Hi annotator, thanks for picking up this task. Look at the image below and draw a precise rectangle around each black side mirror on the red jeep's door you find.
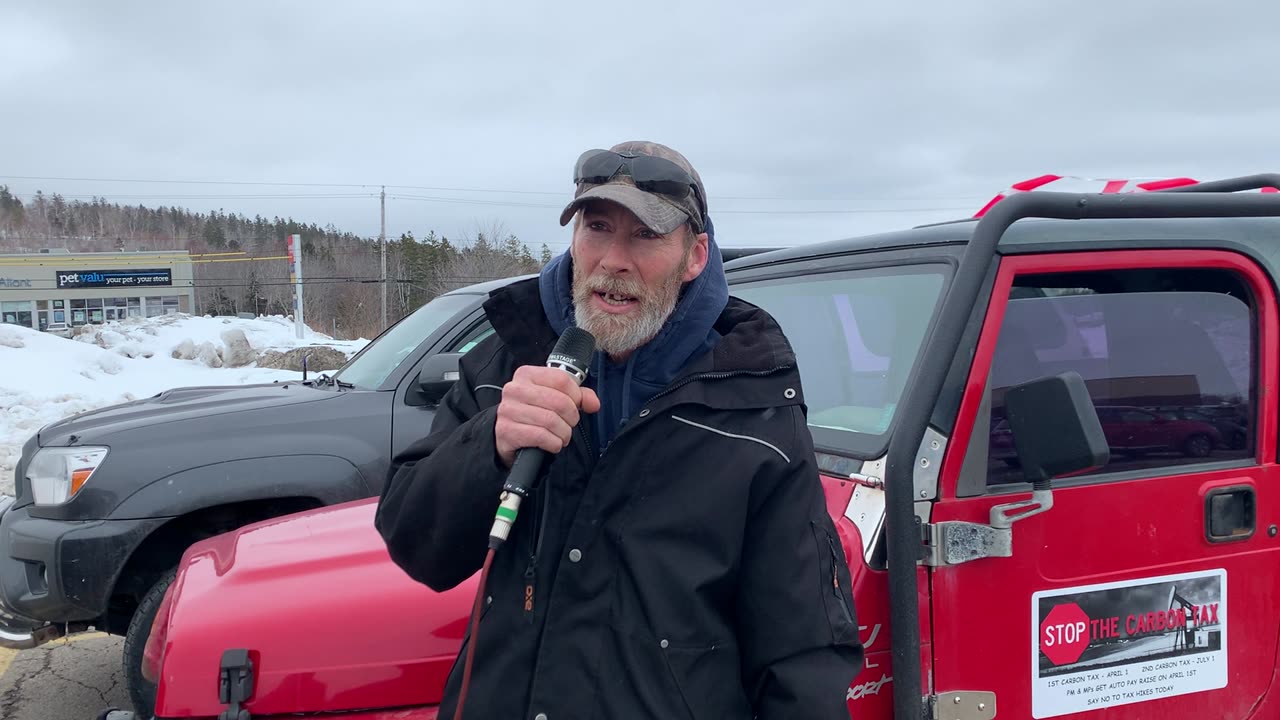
[991,372,1111,528]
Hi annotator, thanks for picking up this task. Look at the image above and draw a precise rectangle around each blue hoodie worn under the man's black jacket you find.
[538,210,728,452]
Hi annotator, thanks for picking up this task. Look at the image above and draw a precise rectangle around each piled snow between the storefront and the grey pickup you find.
[0,314,369,495]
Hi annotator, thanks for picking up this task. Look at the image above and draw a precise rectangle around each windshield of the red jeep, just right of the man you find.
[732,264,947,454]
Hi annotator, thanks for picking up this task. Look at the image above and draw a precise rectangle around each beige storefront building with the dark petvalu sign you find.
[0,250,195,331]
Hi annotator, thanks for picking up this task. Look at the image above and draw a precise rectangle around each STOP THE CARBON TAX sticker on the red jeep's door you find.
[1032,569,1228,717]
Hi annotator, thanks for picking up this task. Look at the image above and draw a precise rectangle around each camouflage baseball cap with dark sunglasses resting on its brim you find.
[561,141,707,234]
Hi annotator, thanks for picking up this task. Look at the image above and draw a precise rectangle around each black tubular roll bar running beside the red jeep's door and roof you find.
[884,184,1280,720]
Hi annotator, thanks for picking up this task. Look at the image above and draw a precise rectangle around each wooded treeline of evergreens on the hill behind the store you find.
[0,186,552,337]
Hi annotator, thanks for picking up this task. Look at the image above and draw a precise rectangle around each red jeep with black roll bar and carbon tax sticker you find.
[112,176,1280,720]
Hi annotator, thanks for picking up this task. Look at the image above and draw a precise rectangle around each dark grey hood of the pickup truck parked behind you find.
[40,382,351,447]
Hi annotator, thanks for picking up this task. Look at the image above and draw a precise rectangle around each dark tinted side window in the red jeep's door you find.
[987,269,1257,484]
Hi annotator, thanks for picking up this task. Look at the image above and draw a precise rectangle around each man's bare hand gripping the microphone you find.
[493,365,600,468]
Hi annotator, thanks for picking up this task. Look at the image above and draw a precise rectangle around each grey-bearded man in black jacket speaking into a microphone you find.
[376,142,863,720]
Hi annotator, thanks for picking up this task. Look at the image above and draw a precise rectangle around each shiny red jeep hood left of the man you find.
[156,498,468,717]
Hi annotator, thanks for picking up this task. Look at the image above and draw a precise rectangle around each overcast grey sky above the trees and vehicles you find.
[0,0,1280,250]
